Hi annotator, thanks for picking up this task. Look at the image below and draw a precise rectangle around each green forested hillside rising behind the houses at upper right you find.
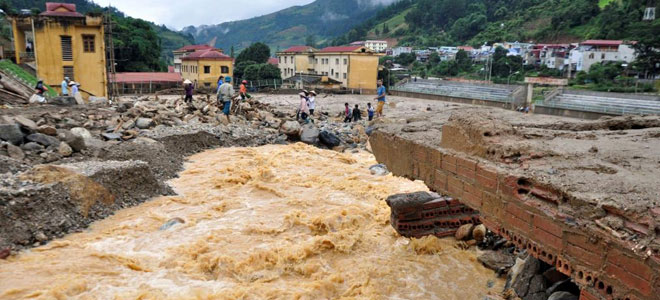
[333,0,658,46]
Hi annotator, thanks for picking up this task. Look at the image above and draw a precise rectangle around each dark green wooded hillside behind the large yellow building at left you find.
[0,0,194,72]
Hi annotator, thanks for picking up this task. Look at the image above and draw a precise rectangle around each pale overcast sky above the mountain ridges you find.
[94,0,314,29]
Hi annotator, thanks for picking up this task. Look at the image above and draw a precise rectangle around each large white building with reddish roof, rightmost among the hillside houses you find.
[570,40,637,72]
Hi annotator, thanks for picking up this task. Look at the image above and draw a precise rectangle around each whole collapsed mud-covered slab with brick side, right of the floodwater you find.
[370,109,660,299]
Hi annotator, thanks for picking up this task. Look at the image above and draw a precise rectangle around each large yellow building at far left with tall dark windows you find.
[11,3,108,97]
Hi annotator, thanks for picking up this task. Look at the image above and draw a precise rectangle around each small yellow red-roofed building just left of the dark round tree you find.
[181,49,234,88]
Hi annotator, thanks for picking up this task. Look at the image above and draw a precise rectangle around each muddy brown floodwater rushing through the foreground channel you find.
[0,144,503,299]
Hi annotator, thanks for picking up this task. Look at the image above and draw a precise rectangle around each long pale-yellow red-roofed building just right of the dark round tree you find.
[277,46,382,93]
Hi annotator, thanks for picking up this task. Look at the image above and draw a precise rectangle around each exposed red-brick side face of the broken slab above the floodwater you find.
[370,131,660,300]
